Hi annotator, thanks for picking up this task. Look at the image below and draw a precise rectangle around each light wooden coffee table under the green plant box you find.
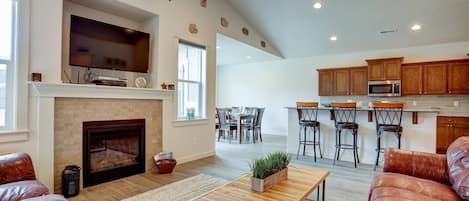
[193,165,329,201]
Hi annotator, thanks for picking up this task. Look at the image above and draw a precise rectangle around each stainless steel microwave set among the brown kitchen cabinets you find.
[368,80,401,96]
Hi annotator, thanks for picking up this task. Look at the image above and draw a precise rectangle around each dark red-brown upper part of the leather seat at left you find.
[0,153,36,184]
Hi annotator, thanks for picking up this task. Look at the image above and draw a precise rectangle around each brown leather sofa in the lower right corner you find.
[368,137,469,201]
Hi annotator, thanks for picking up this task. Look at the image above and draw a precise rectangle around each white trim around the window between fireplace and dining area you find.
[173,37,209,121]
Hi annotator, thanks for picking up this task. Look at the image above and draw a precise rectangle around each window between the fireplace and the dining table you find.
[178,41,206,119]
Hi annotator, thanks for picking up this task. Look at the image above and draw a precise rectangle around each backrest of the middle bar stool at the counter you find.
[331,102,357,126]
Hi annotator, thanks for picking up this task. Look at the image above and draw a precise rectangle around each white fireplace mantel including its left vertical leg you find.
[28,82,174,192]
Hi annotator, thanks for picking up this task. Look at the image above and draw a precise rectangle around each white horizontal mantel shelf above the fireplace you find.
[29,82,174,100]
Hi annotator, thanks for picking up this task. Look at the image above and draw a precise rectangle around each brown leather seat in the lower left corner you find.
[0,153,65,201]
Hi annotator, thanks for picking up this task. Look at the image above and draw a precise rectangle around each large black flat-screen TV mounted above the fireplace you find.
[69,15,150,73]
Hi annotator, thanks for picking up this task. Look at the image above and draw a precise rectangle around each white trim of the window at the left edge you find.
[0,0,30,140]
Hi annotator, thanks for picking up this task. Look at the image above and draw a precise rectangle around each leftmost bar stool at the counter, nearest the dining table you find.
[296,102,322,162]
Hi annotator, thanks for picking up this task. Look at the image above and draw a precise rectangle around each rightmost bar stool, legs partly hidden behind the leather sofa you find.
[373,102,404,171]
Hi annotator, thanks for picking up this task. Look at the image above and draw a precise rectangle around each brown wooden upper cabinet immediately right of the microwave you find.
[402,65,423,96]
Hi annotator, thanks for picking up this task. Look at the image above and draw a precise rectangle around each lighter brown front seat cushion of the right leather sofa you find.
[370,173,460,200]
